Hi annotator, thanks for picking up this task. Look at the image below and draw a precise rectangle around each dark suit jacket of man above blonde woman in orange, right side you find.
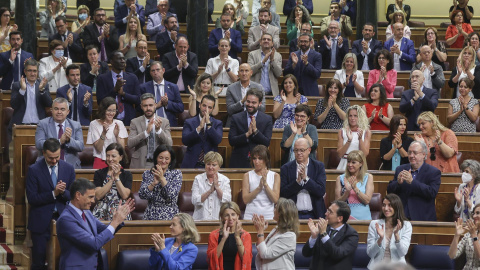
[400,86,438,131]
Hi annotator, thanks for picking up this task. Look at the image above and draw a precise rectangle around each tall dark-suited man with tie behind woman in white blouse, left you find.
[97,51,140,126]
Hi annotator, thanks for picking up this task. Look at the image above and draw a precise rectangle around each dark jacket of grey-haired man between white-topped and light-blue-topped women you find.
[280,158,327,218]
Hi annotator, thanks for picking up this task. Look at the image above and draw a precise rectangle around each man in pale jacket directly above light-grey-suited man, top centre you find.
[247,8,280,51]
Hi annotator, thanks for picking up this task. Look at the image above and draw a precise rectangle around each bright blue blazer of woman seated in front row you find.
[148,237,198,270]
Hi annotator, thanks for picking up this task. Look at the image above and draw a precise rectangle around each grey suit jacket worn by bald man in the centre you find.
[225,81,265,127]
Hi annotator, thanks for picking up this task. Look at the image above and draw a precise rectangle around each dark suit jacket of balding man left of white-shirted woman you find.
[162,51,198,93]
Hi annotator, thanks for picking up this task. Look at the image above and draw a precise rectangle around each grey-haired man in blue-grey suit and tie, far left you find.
[35,97,85,169]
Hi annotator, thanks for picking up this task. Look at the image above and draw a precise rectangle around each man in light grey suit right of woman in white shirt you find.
[248,33,282,97]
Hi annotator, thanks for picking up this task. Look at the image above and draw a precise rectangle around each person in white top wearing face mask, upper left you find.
[39,39,72,92]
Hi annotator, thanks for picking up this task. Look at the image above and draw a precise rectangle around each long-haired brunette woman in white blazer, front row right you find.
[367,194,412,269]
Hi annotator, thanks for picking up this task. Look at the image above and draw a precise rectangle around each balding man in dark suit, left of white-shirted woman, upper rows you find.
[162,37,198,93]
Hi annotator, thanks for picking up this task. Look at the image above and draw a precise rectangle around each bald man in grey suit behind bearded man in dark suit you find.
[226,63,265,127]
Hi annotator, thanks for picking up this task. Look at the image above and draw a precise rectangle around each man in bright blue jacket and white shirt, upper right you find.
[383,23,417,71]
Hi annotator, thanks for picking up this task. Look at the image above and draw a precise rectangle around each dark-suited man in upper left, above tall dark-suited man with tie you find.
[82,8,120,62]
